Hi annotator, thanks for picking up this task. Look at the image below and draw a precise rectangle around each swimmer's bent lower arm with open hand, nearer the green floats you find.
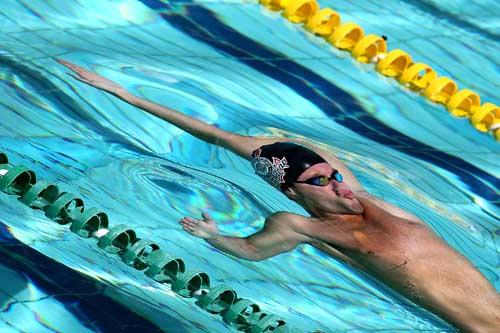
[179,213,308,261]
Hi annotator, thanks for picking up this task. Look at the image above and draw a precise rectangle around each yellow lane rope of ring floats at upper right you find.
[259,0,500,141]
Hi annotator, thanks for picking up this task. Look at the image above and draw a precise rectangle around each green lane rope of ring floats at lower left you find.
[0,152,300,333]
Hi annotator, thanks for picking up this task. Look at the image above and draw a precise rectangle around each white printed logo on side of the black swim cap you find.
[251,149,290,190]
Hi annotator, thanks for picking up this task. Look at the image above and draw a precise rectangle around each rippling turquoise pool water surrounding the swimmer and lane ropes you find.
[0,0,500,333]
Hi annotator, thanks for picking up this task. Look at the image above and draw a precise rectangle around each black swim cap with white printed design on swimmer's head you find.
[250,142,326,190]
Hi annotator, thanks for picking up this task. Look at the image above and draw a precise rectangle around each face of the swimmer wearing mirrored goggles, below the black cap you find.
[285,163,363,214]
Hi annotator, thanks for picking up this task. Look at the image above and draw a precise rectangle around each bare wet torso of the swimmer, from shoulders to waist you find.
[302,198,500,332]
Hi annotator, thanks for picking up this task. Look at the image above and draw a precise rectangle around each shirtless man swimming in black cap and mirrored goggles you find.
[58,60,500,333]
